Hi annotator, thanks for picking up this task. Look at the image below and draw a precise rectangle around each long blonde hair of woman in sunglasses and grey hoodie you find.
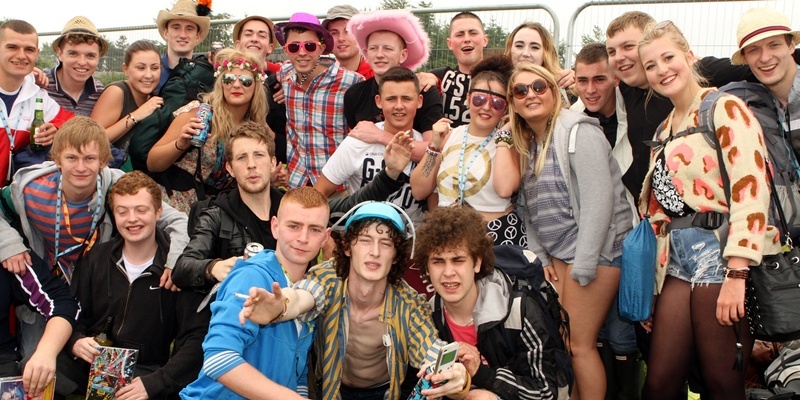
[506,63,565,175]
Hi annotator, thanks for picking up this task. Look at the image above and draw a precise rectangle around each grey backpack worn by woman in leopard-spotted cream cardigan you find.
[684,82,800,230]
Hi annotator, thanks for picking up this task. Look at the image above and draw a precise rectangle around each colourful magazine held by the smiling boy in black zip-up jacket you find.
[86,346,139,400]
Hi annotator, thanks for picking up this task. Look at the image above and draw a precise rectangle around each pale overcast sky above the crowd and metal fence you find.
[7,0,800,60]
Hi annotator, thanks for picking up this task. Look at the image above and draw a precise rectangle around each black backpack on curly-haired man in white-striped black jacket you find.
[494,244,575,399]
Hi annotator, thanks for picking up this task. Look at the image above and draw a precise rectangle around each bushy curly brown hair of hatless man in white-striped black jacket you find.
[414,204,494,281]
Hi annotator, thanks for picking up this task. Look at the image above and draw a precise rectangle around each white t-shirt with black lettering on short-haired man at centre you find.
[322,122,422,224]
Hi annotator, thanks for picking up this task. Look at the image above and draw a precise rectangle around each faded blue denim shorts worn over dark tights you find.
[667,228,725,287]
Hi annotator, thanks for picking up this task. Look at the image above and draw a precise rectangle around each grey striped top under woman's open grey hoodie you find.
[523,141,578,264]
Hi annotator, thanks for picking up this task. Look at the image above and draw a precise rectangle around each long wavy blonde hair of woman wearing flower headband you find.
[202,49,269,142]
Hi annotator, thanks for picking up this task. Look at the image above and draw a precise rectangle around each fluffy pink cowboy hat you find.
[347,10,430,71]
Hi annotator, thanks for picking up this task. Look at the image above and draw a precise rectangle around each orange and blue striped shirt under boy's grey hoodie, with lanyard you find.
[22,172,92,271]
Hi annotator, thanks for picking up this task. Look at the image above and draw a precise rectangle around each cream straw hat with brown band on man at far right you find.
[731,8,800,64]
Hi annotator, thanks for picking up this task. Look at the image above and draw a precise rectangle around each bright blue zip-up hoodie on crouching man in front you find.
[180,250,314,400]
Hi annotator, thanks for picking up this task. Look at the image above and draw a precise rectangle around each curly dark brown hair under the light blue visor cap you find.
[332,217,411,285]
